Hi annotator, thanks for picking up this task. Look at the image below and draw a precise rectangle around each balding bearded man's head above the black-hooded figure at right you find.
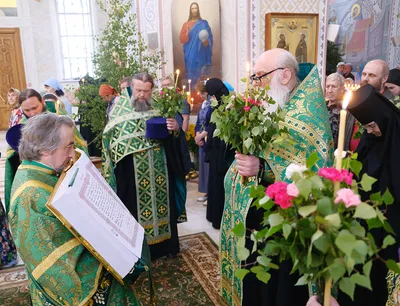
[361,60,389,92]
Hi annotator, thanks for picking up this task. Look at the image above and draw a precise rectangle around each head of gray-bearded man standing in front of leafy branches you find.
[131,72,154,112]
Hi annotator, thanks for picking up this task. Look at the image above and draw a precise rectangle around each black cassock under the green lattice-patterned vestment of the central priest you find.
[114,130,190,260]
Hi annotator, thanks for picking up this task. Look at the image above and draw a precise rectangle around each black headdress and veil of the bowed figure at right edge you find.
[348,85,400,202]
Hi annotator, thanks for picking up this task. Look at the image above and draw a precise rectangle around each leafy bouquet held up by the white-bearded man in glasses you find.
[211,88,288,155]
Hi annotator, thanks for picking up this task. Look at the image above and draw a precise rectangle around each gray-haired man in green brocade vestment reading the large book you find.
[9,113,145,306]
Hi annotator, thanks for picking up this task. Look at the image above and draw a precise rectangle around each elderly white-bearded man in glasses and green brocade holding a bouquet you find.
[220,49,333,306]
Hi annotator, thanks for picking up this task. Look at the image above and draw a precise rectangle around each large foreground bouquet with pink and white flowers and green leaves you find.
[233,154,400,302]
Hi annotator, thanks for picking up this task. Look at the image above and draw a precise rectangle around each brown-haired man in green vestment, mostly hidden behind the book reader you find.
[4,89,88,212]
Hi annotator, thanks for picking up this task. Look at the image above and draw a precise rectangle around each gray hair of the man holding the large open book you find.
[18,113,75,161]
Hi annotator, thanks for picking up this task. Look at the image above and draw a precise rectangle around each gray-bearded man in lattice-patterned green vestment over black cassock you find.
[103,73,190,259]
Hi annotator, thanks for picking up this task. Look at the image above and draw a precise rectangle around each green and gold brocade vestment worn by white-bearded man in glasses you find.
[220,67,333,306]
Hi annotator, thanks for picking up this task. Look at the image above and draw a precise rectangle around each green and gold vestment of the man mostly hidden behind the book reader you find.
[4,111,89,213]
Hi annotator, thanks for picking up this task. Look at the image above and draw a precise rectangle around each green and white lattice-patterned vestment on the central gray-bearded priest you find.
[102,96,171,245]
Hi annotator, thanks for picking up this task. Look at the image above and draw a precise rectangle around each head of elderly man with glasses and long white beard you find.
[250,48,299,111]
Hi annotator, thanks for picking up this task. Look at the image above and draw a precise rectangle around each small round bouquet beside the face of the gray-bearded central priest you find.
[153,87,185,118]
